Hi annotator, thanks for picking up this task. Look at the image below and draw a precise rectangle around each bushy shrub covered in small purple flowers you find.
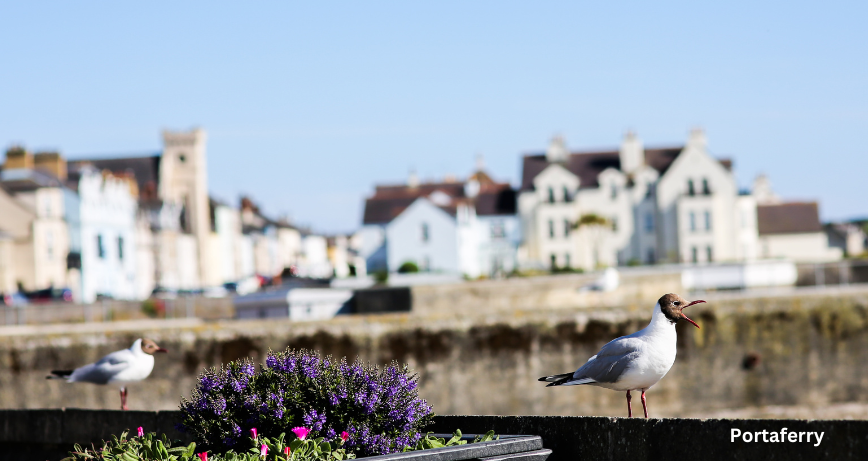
[178,349,432,456]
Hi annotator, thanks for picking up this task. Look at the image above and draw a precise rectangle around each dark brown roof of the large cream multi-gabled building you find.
[521,146,688,190]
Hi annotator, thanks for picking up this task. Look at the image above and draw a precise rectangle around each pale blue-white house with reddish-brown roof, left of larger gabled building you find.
[357,171,521,277]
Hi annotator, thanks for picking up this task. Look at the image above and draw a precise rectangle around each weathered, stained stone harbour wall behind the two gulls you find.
[0,287,868,417]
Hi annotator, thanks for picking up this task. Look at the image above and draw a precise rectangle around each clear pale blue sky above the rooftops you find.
[0,1,868,232]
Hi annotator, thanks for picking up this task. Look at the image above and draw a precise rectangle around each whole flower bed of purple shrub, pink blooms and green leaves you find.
[61,350,544,461]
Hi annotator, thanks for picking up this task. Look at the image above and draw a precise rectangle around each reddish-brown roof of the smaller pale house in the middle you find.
[362,172,516,224]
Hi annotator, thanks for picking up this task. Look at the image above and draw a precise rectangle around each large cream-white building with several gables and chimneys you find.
[518,130,757,270]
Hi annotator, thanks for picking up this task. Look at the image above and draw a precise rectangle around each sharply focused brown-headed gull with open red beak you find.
[539,293,705,418]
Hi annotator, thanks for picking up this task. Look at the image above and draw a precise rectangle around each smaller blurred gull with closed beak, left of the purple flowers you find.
[46,338,168,410]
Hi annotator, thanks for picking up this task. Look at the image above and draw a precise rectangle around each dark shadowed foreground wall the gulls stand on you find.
[0,409,868,461]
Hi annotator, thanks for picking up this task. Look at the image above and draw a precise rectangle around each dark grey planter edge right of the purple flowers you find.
[360,434,552,461]
